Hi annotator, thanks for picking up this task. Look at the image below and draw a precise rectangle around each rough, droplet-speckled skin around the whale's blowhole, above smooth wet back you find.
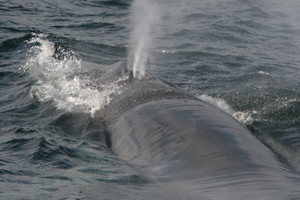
[95,62,197,124]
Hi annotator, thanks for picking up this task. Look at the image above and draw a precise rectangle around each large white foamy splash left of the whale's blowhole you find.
[22,34,119,115]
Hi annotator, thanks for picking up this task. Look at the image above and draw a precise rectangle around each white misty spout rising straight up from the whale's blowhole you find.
[128,0,159,79]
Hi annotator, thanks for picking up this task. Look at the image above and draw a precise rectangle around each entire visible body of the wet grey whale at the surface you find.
[85,63,300,200]
